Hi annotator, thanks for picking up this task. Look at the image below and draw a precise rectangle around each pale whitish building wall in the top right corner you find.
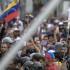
[57,0,70,16]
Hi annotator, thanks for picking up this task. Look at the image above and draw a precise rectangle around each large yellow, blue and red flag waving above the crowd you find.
[0,0,19,22]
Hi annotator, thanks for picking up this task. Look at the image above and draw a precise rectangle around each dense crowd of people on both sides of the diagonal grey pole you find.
[0,14,70,70]
